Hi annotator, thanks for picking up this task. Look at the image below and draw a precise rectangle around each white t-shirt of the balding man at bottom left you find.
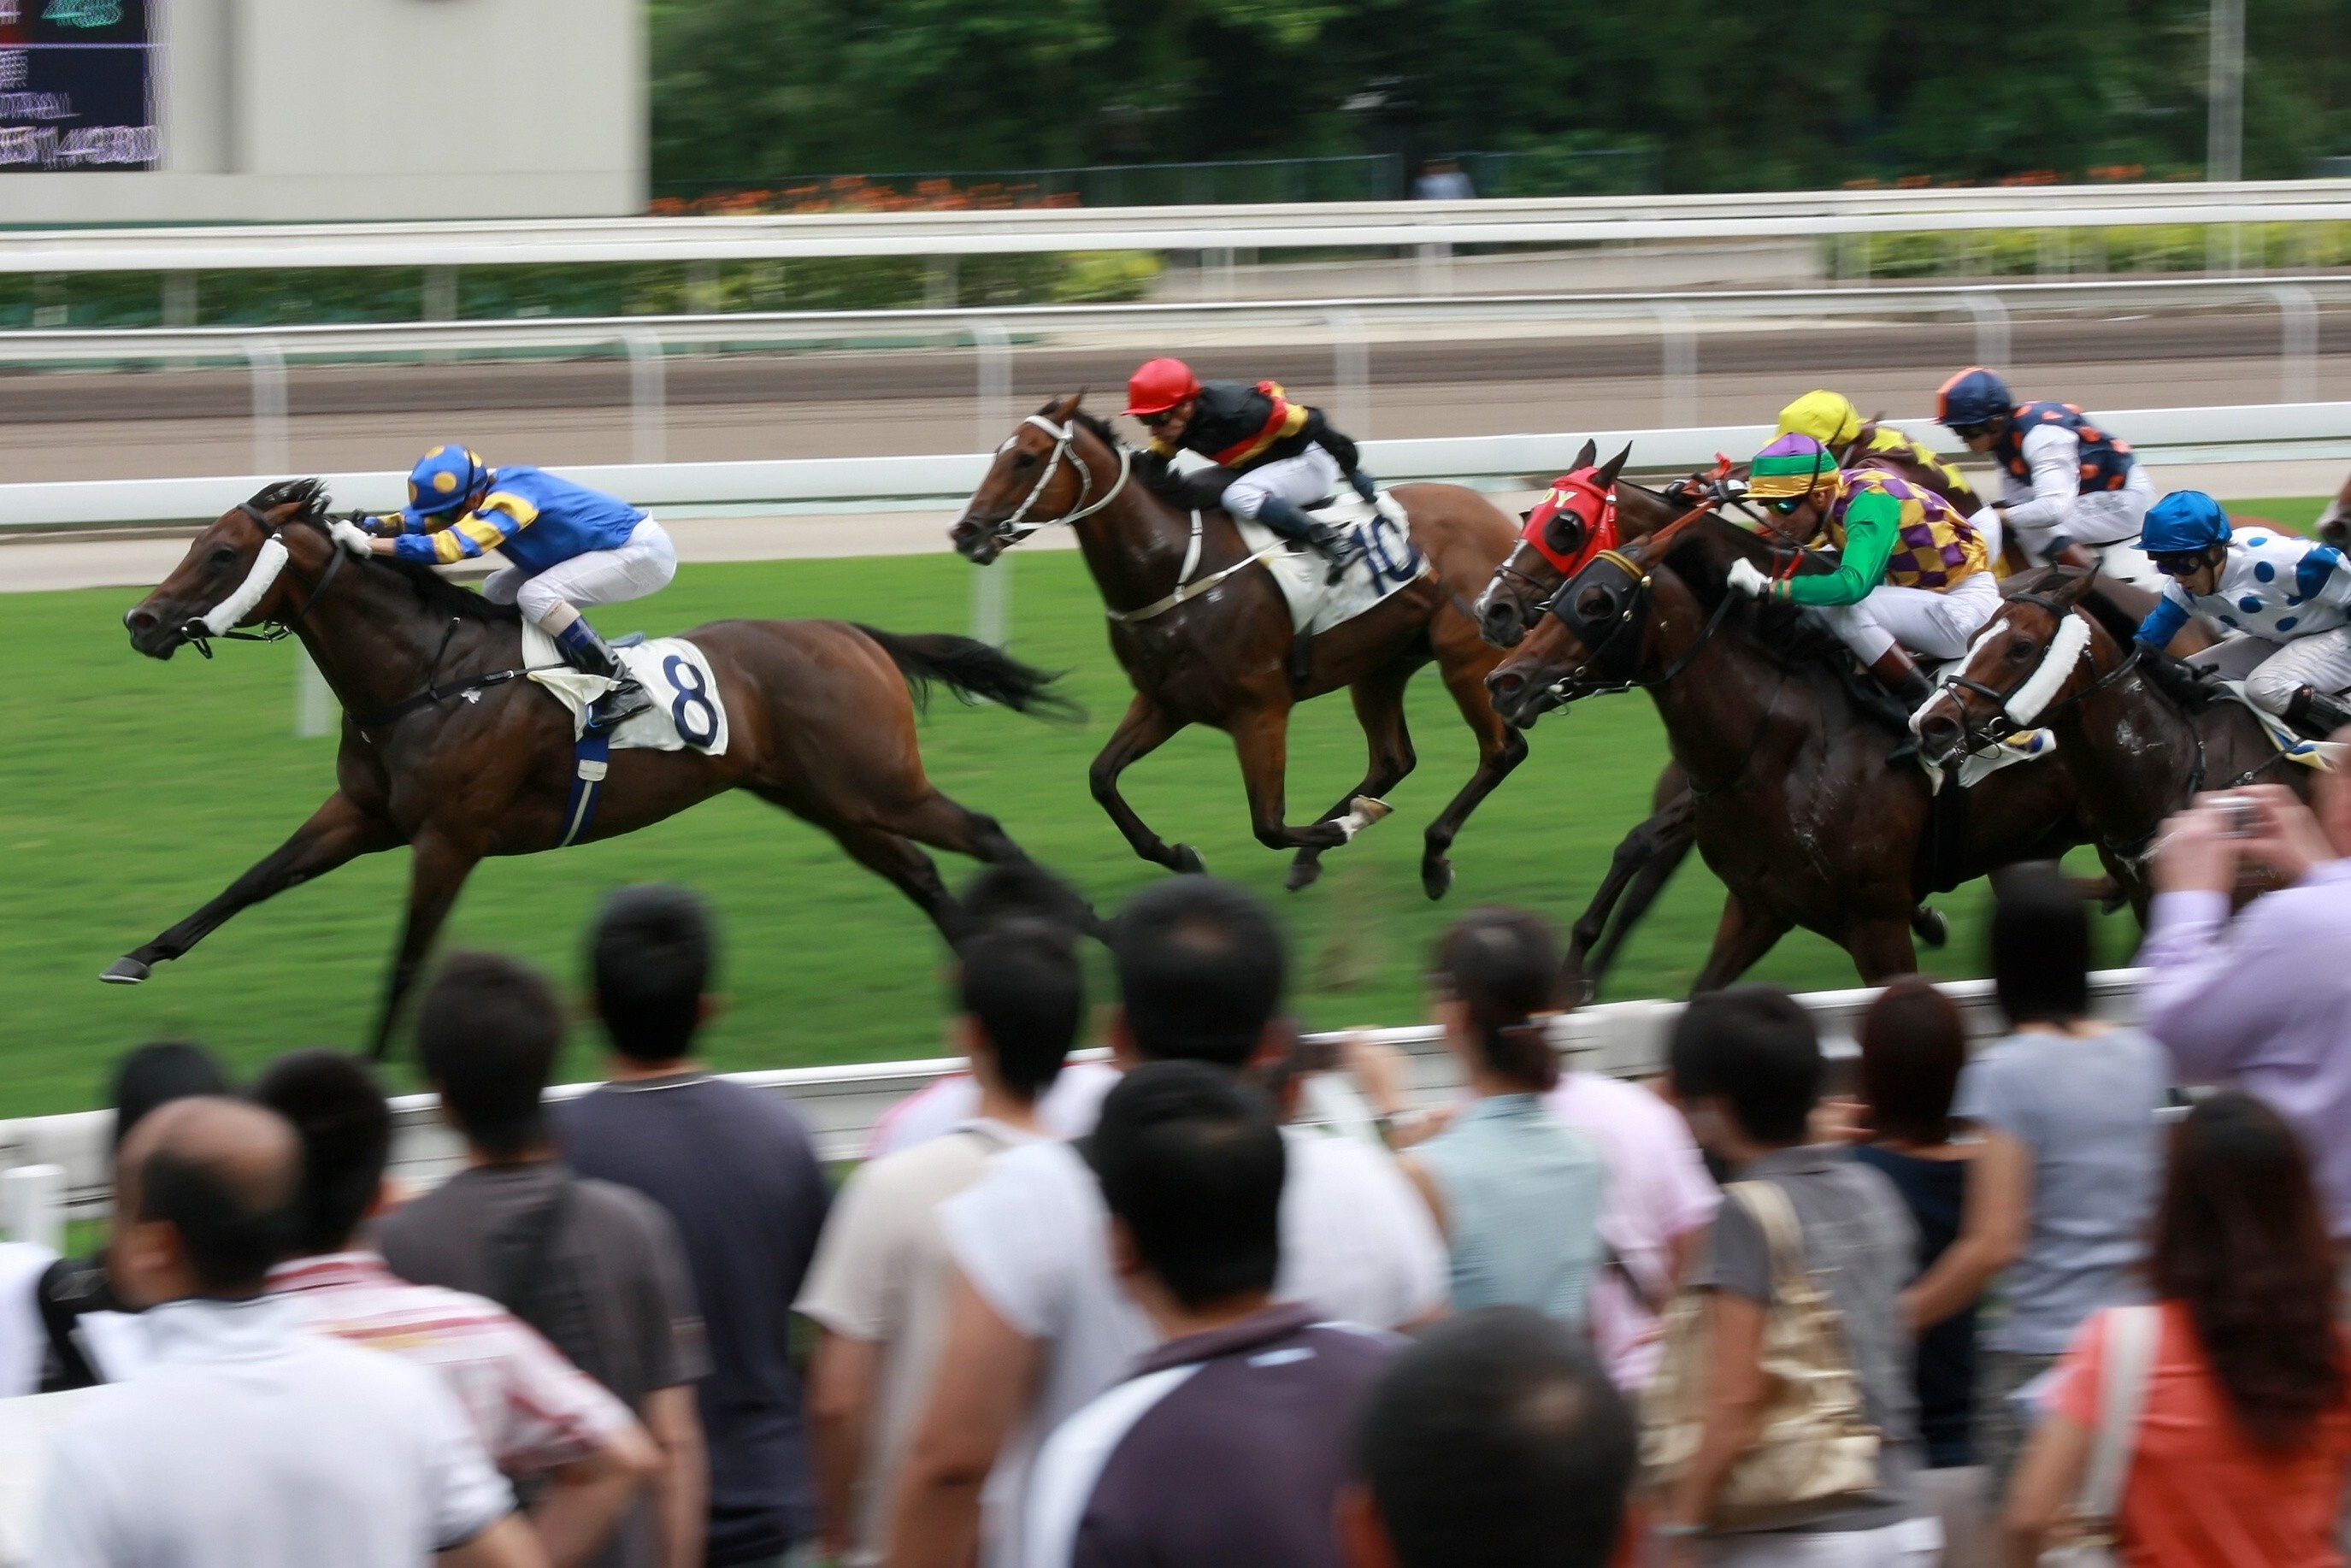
[33,1295,515,1568]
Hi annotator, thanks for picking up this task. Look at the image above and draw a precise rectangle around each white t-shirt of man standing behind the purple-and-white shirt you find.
[938,1129,1448,1568]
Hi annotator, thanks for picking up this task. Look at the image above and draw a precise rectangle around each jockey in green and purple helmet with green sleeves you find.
[1730,435,2000,742]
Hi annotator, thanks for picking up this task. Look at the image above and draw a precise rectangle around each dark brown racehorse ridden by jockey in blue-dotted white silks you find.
[1912,567,2311,926]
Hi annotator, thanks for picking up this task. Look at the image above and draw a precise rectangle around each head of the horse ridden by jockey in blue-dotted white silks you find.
[1912,567,2097,766]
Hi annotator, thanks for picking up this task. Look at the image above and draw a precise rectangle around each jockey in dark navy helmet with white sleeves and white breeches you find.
[1935,364,2163,590]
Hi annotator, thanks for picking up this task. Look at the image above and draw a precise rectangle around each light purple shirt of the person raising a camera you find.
[2140,860,2351,1241]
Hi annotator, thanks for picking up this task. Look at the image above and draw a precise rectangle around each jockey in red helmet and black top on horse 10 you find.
[1126,360,1378,564]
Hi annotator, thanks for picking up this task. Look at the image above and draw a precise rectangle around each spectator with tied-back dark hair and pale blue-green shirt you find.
[1404,910,1606,1326]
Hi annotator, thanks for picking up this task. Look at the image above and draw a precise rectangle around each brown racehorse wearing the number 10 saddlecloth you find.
[950,392,1526,898]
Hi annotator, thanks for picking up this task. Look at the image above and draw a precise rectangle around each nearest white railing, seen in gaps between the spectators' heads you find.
[0,969,2140,1229]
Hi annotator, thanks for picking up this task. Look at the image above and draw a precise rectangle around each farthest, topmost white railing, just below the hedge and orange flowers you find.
[0,181,2351,273]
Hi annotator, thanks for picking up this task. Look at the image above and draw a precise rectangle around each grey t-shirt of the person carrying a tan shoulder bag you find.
[1693,1145,1924,1530]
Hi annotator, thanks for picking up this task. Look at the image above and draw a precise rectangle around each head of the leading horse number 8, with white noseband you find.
[122,480,336,658]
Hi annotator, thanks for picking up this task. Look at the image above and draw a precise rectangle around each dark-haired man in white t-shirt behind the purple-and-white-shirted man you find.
[889,877,1444,1568]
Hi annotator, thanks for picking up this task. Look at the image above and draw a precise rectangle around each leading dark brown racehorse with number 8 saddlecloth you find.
[106,480,1081,1056]
